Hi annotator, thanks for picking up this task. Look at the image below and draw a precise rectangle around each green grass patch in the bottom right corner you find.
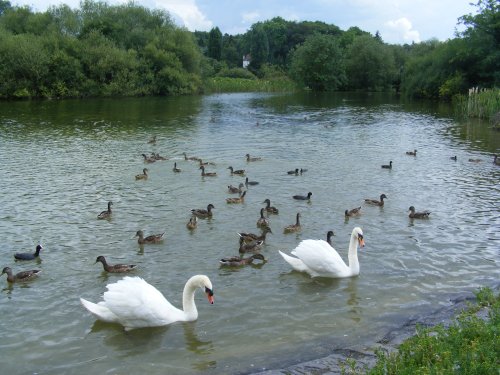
[366,288,500,375]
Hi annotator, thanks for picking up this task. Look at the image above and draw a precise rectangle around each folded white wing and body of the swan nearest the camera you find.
[101,277,185,328]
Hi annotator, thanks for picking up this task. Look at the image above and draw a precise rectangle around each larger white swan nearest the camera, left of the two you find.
[80,275,214,330]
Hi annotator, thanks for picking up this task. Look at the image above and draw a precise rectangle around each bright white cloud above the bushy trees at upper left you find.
[156,0,213,31]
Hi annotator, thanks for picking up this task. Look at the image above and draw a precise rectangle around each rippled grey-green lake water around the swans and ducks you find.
[0,94,500,374]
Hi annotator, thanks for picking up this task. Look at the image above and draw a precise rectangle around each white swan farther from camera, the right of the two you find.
[280,227,365,278]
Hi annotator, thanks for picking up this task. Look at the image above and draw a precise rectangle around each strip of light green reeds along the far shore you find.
[204,77,296,93]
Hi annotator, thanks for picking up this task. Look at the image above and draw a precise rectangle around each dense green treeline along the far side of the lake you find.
[0,0,500,99]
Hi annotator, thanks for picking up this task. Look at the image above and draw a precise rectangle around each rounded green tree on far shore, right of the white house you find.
[290,34,346,91]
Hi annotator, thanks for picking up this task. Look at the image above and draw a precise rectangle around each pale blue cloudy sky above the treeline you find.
[10,0,477,44]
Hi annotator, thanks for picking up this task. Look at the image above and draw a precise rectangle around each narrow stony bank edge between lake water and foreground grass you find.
[256,284,500,375]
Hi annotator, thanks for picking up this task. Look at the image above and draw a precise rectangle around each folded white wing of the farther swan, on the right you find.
[292,240,351,277]
